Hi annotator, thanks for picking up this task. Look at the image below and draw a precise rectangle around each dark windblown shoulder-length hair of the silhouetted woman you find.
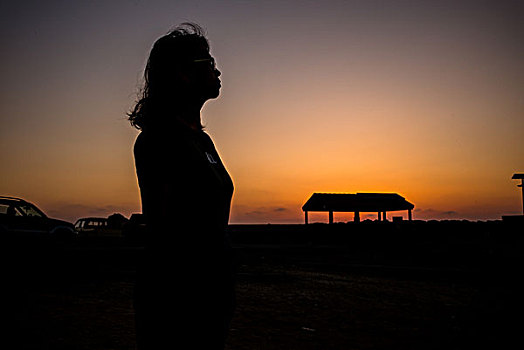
[127,23,209,129]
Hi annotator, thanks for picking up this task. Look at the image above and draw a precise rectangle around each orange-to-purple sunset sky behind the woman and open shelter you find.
[0,0,524,223]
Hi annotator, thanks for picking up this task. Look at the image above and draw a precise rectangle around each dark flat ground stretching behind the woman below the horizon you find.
[2,221,524,350]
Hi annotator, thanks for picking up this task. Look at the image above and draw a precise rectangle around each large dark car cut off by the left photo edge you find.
[0,196,77,239]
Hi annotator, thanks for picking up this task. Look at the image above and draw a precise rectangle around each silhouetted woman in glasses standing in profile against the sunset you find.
[129,23,234,349]
